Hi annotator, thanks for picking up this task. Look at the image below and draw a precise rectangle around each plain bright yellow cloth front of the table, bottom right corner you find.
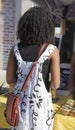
[53,114,75,130]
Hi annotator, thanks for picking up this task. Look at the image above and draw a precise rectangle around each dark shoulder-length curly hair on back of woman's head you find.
[17,7,54,45]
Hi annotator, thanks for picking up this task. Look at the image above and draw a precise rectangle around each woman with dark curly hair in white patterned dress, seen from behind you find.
[6,7,60,130]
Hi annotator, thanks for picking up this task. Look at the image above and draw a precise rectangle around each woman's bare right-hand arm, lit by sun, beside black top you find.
[49,48,60,89]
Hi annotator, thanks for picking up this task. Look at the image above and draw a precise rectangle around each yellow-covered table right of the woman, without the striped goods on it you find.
[53,95,75,130]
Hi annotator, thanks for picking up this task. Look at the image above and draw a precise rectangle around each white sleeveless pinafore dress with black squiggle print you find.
[10,43,56,130]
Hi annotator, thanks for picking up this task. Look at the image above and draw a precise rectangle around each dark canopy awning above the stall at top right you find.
[31,0,75,20]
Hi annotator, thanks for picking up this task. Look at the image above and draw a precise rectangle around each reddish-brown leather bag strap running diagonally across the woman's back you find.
[21,43,48,92]
